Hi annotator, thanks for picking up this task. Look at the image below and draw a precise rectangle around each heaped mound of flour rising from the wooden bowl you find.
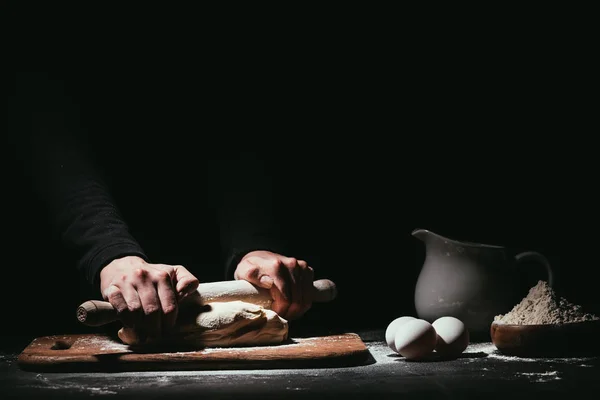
[494,281,600,325]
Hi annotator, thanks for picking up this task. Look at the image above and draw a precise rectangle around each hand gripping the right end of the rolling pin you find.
[233,250,314,320]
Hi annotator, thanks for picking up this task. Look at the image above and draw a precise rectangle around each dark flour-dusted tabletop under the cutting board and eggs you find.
[0,330,600,400]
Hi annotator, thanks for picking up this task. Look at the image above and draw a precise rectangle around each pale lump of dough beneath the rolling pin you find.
[118,301,288,348]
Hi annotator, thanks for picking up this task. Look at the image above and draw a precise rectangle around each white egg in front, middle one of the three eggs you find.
[394,319,437,360]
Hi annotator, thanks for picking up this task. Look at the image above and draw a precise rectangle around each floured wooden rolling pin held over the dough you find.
[77,279,337,326]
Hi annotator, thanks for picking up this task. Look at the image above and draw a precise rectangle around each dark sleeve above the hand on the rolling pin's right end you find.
[208,149,288,280]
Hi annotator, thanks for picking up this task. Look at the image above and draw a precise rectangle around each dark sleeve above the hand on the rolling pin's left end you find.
[9,72,146,288]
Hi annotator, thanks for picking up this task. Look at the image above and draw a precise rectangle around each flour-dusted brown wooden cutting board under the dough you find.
[17,333,374,372]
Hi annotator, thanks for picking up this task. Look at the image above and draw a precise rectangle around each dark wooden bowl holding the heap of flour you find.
[490,321,600,358]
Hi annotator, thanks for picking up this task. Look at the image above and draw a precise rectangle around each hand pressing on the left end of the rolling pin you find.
[100,256,199,342]
